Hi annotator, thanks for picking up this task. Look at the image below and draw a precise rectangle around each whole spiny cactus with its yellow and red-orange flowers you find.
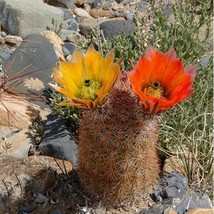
[49,46,196,205]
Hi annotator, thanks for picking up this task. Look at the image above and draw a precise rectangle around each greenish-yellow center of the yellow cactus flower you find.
[76,79,101,100]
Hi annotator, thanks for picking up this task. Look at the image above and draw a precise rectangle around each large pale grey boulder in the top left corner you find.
[0,0,64,37]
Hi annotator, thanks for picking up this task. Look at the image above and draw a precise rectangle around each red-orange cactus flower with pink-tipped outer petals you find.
[128,47,196,114]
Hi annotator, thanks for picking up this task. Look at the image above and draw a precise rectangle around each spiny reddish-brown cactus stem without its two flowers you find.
[78,76,159,204]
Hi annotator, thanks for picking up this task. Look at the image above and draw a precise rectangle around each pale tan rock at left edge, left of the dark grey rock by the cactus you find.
[0,126,35,158]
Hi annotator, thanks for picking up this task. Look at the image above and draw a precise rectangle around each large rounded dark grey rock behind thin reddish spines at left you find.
[3,34,58,107]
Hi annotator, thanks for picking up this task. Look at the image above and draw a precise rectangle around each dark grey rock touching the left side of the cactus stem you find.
[39,114,77,167]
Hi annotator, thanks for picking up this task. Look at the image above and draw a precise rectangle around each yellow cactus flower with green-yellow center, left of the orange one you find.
[50,46,120,109]
